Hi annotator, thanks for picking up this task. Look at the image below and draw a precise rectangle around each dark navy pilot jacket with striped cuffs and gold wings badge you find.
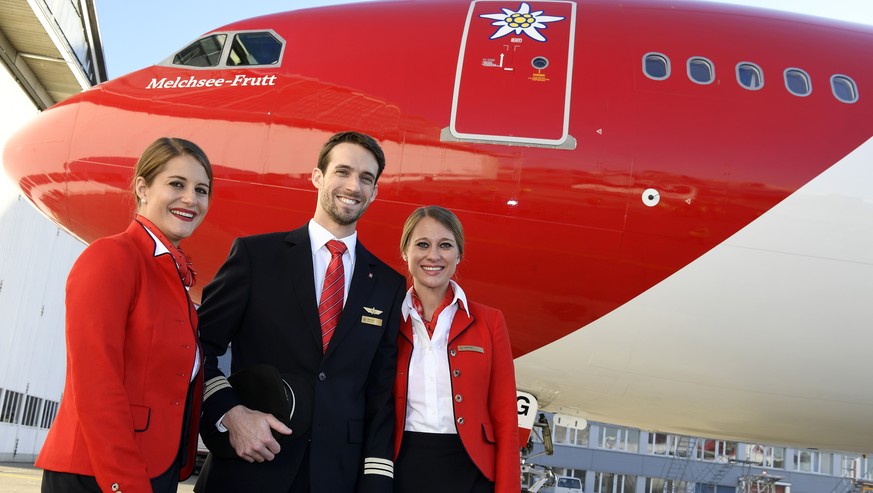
[199,225,405,493]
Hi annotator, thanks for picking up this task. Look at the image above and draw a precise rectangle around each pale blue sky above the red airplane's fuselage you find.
[97,0,873,78]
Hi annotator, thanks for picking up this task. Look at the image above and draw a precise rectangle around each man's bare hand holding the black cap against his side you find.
[221,405,291,462]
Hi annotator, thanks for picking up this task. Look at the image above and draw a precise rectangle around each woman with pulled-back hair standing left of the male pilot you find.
[36,138,212,493]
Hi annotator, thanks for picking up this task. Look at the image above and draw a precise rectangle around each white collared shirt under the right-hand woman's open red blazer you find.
[401,281,470,433]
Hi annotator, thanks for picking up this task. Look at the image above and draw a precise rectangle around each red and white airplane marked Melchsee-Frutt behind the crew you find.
[4,0,873,453]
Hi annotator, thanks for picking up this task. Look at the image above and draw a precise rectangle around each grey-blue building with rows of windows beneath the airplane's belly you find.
[522,414,873,493]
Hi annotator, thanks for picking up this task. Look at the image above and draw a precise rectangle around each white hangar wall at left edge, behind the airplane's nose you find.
[0,57,85,462]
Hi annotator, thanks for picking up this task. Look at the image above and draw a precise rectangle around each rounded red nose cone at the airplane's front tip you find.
[3,104,78,229]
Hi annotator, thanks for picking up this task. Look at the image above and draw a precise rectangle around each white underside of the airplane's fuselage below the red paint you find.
[515,139,873,452]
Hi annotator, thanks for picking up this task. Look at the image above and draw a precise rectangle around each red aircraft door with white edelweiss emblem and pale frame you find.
[442,0,576,148]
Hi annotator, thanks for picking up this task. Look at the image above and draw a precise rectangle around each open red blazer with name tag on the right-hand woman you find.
[394,303,521,493]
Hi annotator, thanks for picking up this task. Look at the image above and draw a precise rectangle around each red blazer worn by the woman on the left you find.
[36,221,203,493]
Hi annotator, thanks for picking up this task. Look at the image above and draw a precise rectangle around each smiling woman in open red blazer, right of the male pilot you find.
[394,206,521,493]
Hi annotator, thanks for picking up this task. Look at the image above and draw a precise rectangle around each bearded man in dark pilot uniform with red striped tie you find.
[195,132,405,493]
